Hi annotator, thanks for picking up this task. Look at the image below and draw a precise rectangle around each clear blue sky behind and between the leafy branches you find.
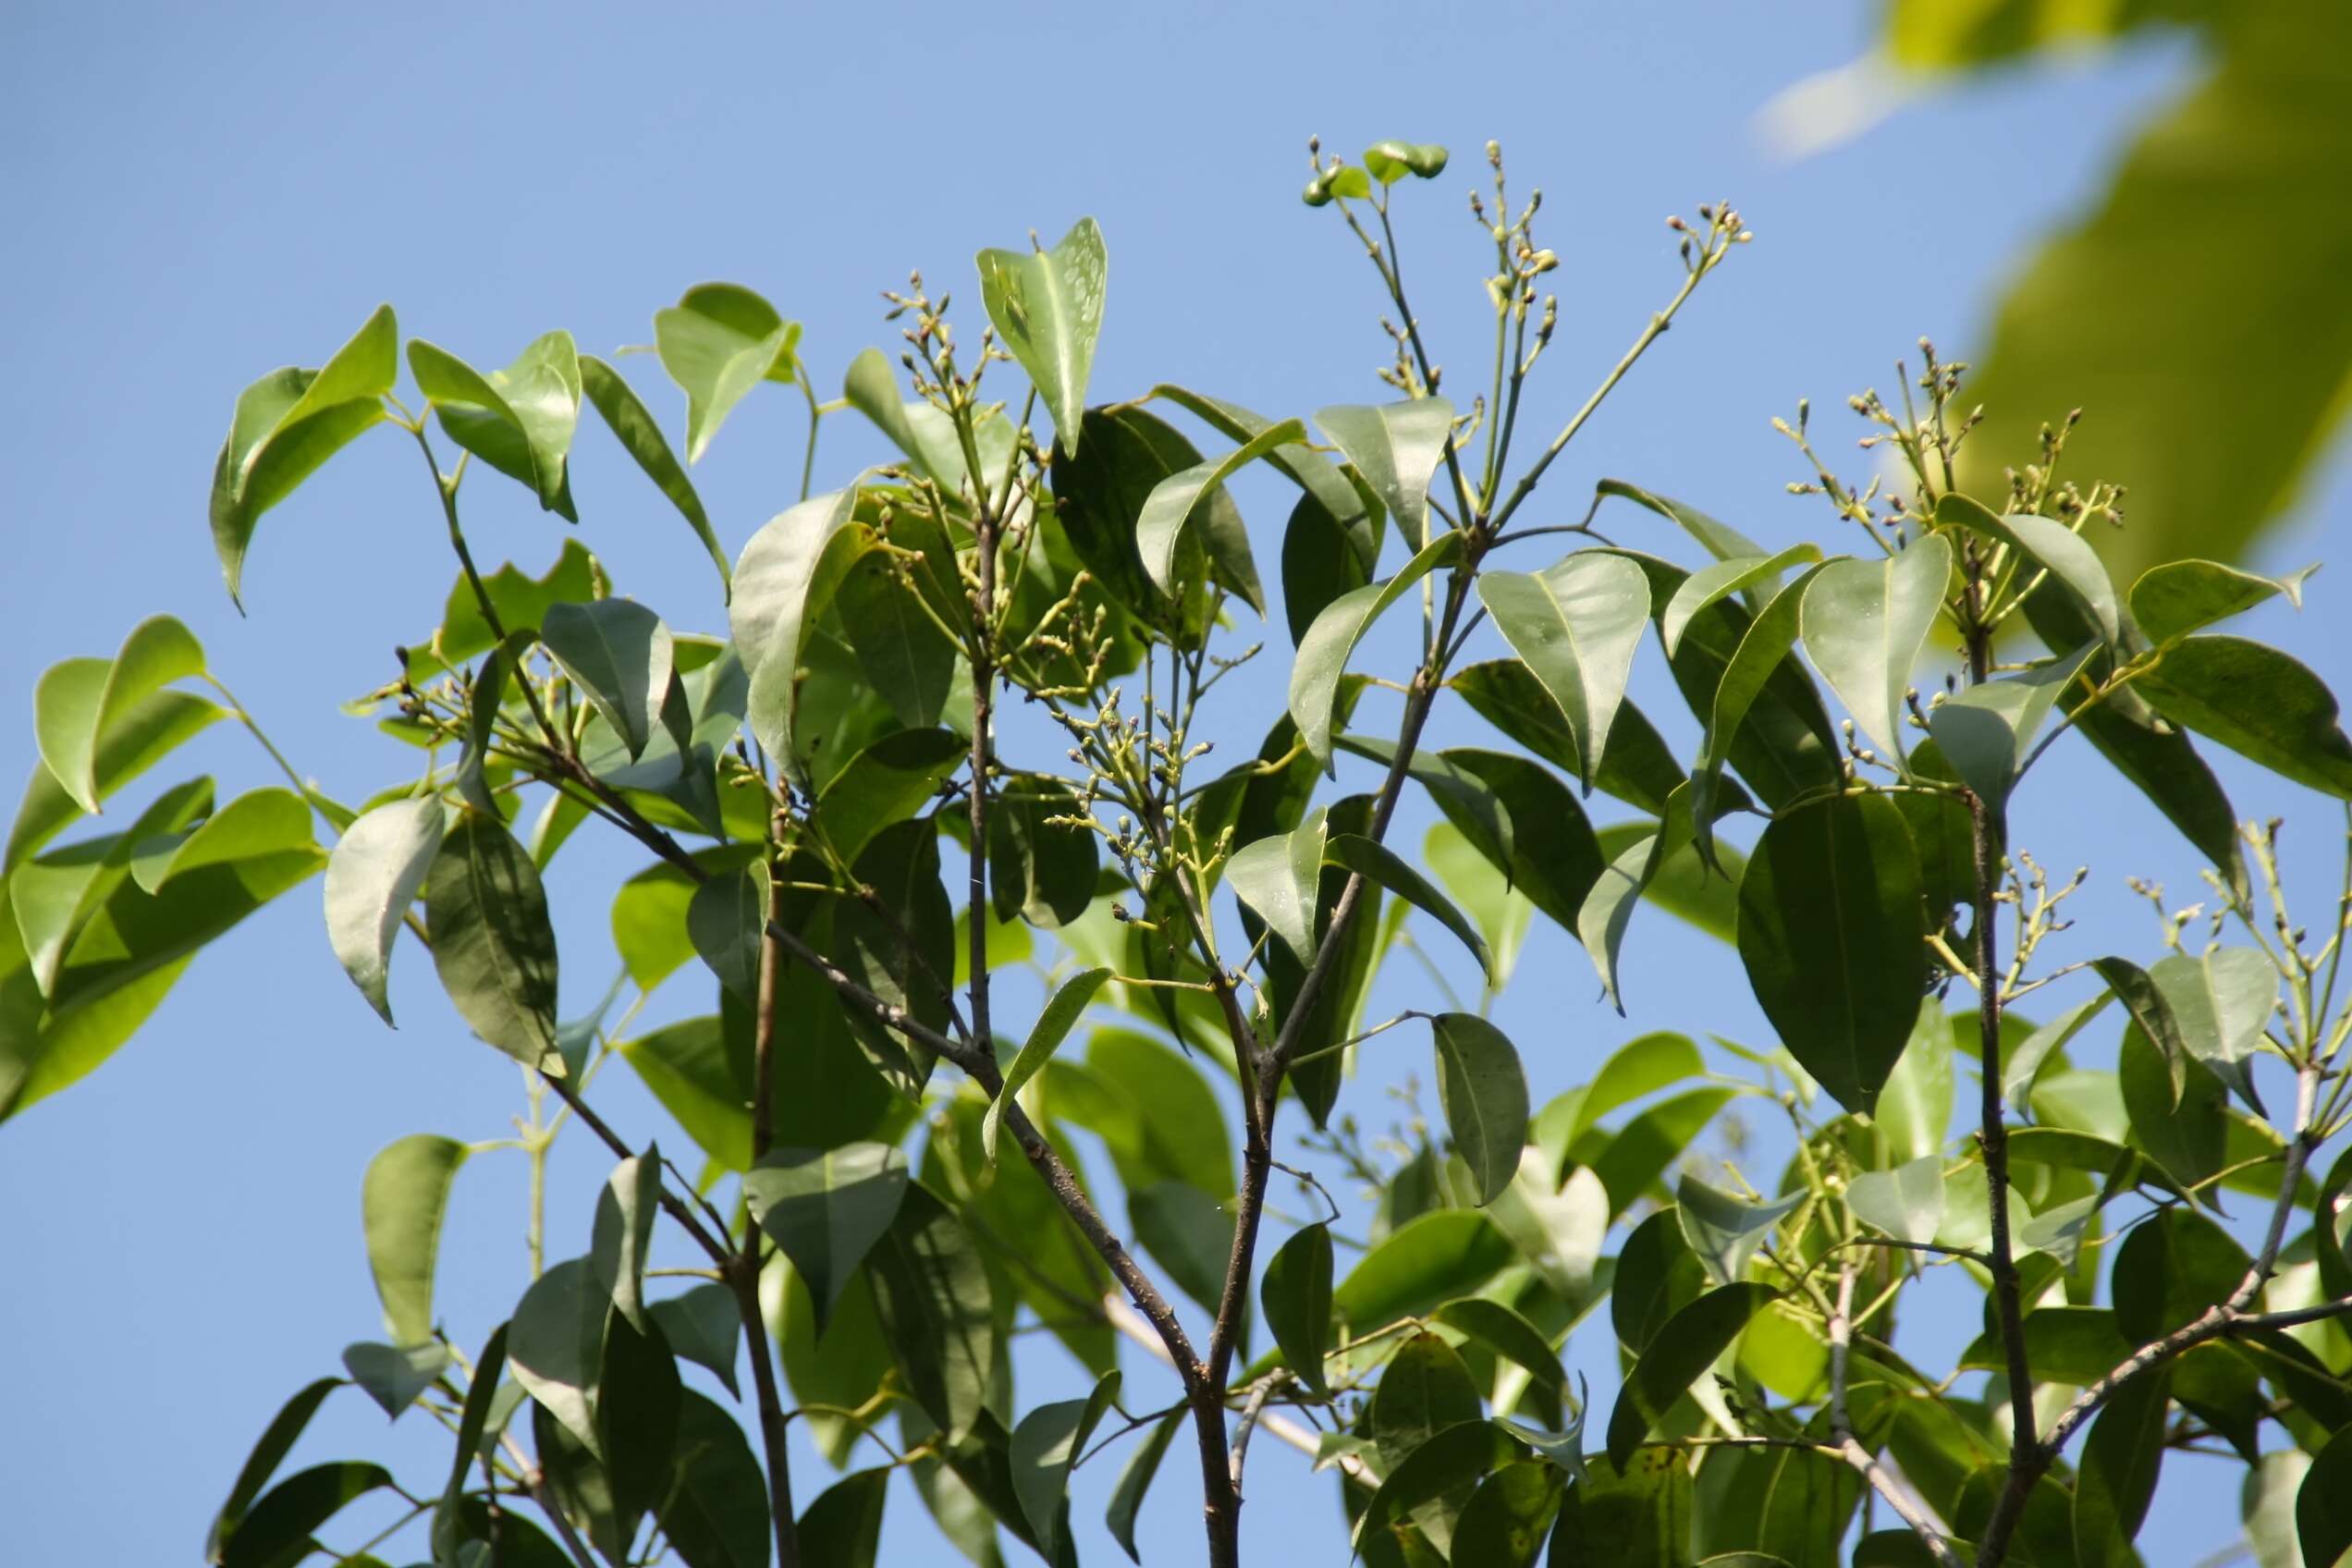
[0,0,2352,1568]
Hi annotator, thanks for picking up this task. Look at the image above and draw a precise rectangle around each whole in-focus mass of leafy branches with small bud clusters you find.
[13,131,2352,1568]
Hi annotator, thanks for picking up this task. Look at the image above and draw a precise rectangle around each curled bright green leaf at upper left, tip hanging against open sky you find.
[212,306,399,604]
